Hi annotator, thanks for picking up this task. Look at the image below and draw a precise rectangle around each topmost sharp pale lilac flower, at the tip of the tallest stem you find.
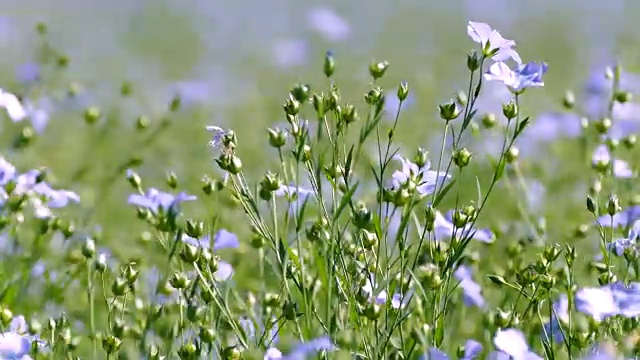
[467,21,522,64]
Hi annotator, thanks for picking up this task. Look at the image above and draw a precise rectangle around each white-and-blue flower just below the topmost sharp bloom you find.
[484,61,548,93]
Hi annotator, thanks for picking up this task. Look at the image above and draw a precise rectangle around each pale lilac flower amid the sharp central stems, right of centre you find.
[391,155,451,195]
